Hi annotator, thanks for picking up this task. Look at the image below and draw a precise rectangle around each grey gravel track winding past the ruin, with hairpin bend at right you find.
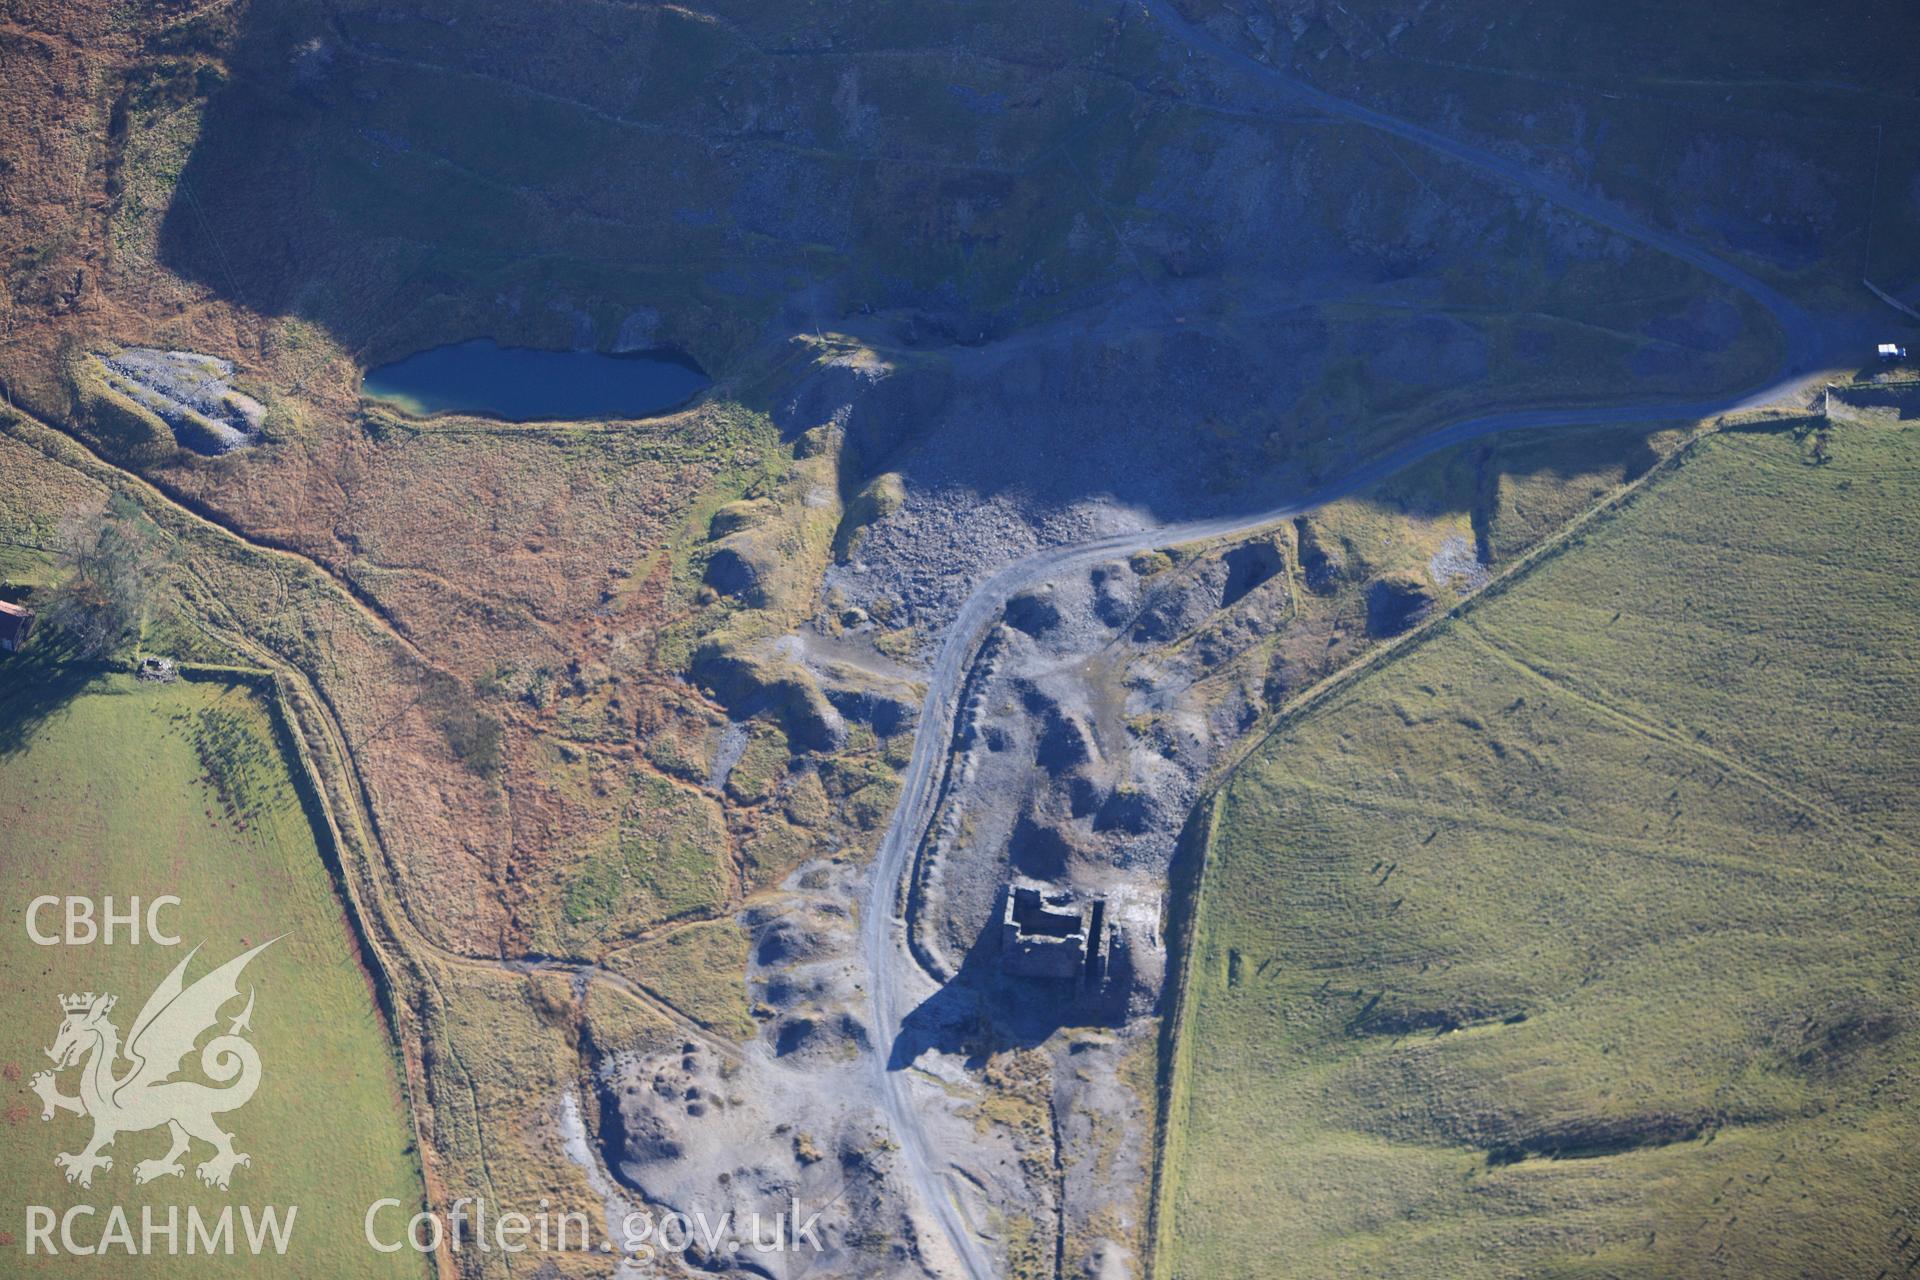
[860,12,1822,1280]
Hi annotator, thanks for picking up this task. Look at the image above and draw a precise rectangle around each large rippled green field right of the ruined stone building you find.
[1158,430,1920,1280]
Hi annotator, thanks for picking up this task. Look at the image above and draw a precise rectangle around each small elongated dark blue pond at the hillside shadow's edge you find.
[361,338,712,422]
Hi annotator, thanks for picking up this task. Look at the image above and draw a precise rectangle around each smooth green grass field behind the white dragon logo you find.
[0,675,424,1278]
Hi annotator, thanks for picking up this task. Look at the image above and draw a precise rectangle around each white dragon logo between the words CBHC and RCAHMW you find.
[33,938,278,1190]
